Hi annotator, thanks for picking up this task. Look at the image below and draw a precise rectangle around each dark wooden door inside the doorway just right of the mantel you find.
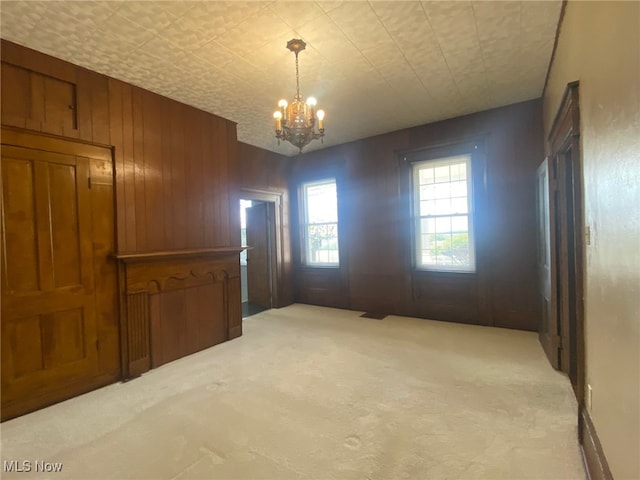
[246,202,271,308]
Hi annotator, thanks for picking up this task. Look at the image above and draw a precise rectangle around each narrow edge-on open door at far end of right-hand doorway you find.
[536,158,560,368]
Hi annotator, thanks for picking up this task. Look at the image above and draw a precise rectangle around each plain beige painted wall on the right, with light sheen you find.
[543,1,640,479]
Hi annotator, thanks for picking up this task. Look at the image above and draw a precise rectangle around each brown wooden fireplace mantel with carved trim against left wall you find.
[113,247,244,379]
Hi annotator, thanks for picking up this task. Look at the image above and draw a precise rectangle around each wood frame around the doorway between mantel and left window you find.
[238,188,286,308]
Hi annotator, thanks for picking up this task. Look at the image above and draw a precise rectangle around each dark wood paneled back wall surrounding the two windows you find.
[292,100,543,330]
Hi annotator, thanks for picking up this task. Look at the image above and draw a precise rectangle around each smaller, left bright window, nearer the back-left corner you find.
[301,178,339,267]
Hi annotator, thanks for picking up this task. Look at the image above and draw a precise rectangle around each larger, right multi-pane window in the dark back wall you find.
[413,155,475,272]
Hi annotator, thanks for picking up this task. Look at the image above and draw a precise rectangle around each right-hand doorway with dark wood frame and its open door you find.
[538,82,585,408]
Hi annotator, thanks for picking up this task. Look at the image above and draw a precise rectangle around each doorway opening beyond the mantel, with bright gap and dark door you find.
[240,198,275,318]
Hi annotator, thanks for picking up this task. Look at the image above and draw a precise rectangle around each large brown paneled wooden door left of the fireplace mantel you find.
[0,145,99,418]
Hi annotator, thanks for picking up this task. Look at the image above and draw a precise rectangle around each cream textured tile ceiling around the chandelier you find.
[0,0,561,155]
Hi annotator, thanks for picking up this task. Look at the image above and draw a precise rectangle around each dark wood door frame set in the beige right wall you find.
[547,82,585,410]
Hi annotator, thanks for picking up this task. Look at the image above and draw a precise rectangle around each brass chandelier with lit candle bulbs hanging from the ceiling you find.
[273,38,324,152]
